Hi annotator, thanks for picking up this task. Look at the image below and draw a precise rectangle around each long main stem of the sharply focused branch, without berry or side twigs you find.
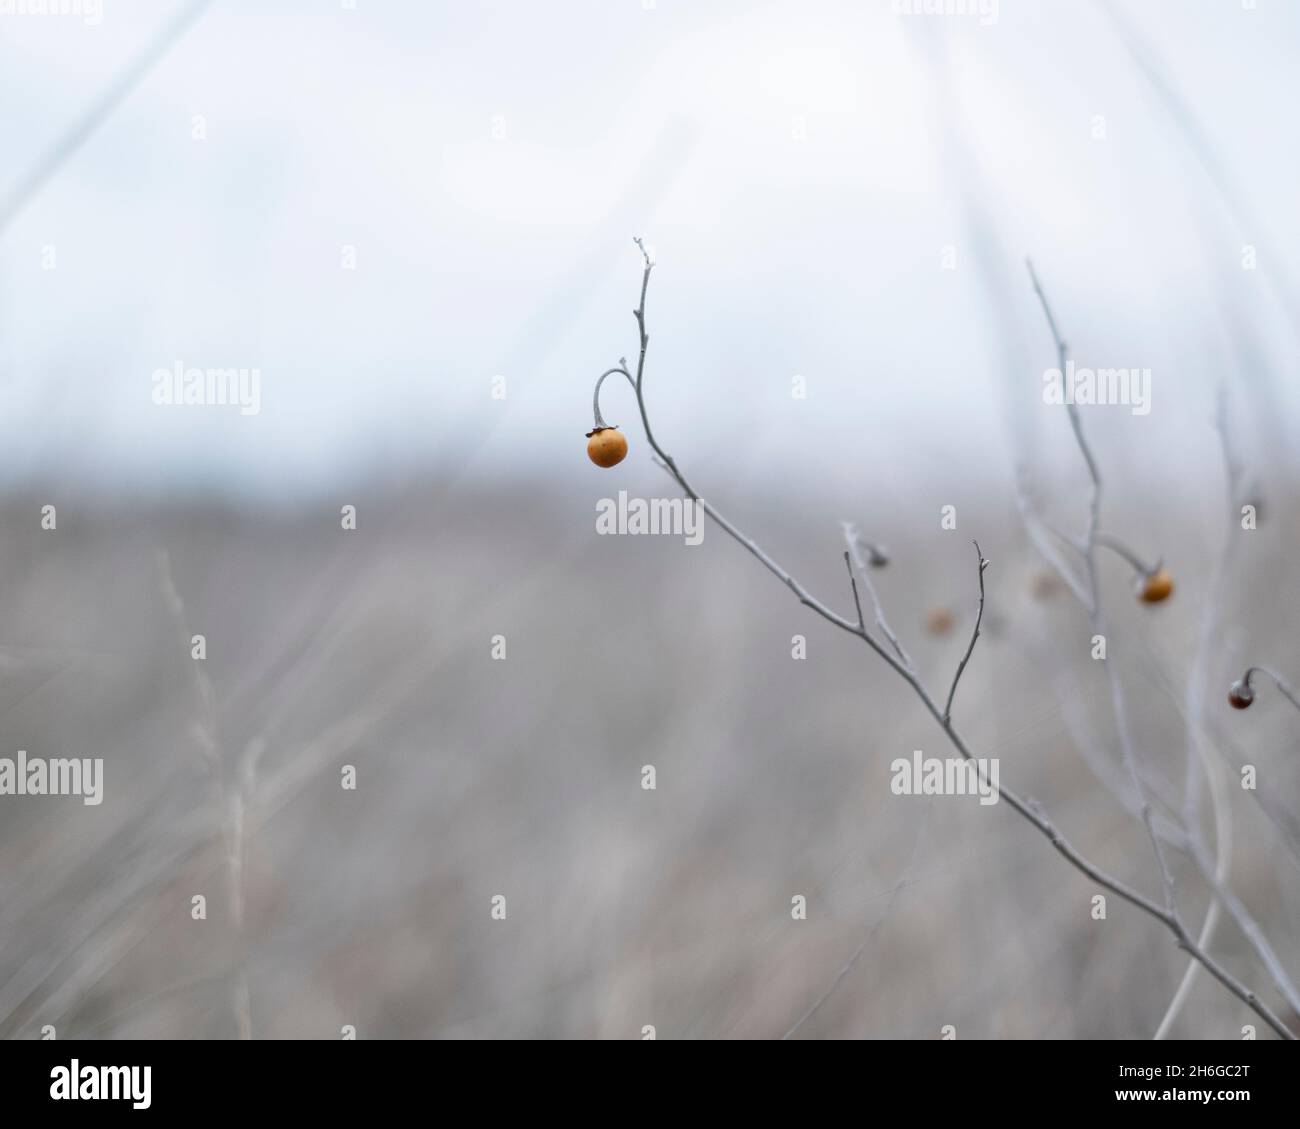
[603,239,1295,1039]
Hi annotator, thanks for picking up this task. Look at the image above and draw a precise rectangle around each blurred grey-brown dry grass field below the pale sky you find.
[0,470,1300,1038]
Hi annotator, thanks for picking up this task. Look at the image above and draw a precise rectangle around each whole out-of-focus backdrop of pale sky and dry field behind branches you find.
[0,0,1300,1038]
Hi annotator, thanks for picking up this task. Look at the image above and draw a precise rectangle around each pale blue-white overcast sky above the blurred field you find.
[0,0,1300,494]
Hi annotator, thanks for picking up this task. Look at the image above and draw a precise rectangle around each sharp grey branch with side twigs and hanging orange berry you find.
[589,238,1295,1039]
